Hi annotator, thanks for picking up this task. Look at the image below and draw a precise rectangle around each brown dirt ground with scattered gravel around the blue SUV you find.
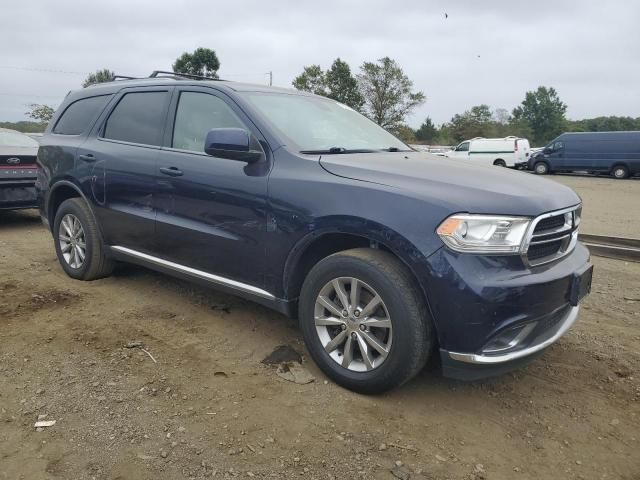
[0,177,640,480]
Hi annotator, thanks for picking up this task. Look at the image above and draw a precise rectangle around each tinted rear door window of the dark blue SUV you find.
[104,92,167,145]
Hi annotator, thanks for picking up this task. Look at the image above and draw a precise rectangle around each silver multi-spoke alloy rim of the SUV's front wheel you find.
[314,277,392,372]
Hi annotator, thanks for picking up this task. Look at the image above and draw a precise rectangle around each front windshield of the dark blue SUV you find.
[242,92,411,153]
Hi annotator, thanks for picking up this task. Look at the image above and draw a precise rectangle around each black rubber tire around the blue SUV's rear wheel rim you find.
[53,198,114,280]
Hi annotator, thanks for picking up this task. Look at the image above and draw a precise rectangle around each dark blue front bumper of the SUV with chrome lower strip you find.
[427,243,591,380]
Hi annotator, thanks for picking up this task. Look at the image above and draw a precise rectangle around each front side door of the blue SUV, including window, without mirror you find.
[155,87,270,288]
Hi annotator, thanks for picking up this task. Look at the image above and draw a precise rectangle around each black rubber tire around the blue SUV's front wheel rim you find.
[299,248,433,393]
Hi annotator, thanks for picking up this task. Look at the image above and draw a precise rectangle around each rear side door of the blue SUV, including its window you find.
[78,87,172,253]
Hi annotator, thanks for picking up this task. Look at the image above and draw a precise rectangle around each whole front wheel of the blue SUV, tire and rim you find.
[299,248,432,393]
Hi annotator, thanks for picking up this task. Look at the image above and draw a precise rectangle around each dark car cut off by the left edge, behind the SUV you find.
[0,128,38,210]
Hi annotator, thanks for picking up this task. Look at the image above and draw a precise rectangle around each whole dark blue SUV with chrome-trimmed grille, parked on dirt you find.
[37,72,592,392]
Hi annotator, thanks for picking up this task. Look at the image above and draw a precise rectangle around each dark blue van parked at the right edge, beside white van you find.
[528,132,640,178]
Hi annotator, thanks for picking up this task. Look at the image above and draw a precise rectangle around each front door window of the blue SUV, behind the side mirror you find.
[172,92,245,152]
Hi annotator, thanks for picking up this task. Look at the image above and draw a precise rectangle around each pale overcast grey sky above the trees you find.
[0,0,640,127]
